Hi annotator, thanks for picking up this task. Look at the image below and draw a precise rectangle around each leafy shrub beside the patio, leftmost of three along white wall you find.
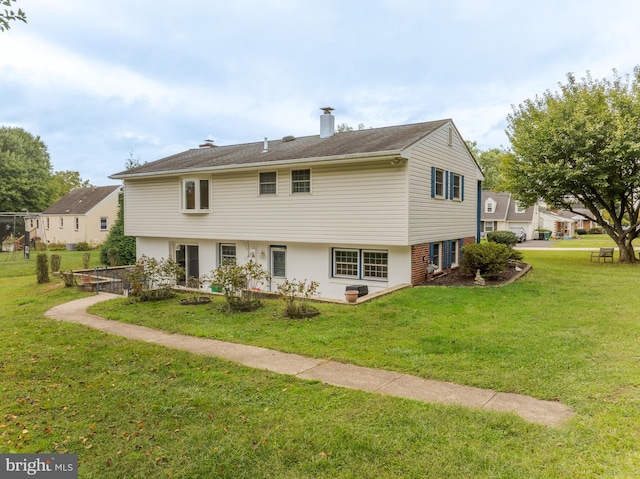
[126,255,184,301]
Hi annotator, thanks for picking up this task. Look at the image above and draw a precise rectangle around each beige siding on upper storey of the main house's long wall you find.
[125,161,407,245]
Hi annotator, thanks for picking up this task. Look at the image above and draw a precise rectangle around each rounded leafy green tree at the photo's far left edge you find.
[0,127,54,211]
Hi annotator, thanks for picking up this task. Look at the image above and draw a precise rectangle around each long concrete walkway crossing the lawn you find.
[45,293,574,427]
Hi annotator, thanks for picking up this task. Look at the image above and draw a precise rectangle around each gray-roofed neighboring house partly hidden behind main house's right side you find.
[480,191,539,240]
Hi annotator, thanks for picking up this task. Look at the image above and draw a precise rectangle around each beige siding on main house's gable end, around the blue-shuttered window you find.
[407,125,478,244]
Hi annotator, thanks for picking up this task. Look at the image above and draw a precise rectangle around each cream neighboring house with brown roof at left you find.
[40,185,122,249]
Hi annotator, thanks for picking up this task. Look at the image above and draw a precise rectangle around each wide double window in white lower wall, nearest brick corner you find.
[333,248,389,280]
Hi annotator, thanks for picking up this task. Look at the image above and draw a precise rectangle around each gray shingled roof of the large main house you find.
[111,120,451,179]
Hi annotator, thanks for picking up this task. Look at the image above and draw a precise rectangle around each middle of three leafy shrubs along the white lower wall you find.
[211,261,269,311]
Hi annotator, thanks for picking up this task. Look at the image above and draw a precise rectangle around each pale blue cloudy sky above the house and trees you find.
[0,0,640,185]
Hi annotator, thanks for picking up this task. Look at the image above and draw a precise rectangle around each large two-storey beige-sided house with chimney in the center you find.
[111,109,483,299]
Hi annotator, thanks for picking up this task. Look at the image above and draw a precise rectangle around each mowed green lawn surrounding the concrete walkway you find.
[0,251,640,478]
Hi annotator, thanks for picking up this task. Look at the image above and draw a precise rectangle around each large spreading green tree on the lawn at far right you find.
[504,67,640,263]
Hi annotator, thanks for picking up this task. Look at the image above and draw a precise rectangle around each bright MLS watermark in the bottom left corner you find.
[0,454,78,479]
